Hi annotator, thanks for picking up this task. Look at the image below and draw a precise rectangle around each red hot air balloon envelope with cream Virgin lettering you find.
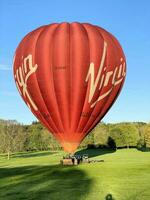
[14,22,126,152]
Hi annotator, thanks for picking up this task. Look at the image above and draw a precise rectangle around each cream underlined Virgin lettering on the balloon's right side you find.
[85,41,126,108]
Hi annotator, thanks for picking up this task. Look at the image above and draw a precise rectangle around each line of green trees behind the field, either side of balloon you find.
[0,120,150,157]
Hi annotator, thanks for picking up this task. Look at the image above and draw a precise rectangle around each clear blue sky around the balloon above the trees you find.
[0,0,150,124]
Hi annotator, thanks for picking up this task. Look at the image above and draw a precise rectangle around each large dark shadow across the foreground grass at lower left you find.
[0,165,92,200]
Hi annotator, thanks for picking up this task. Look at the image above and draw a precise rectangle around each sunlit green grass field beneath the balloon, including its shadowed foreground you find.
[0,149,150,200]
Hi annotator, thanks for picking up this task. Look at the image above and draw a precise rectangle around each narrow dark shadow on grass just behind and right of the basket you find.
[75,148,116,158]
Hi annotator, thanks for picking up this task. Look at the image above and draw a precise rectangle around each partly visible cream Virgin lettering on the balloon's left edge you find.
[15,54,38,111]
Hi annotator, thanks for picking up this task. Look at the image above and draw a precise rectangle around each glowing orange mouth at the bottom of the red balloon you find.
[61,142,79,153]
